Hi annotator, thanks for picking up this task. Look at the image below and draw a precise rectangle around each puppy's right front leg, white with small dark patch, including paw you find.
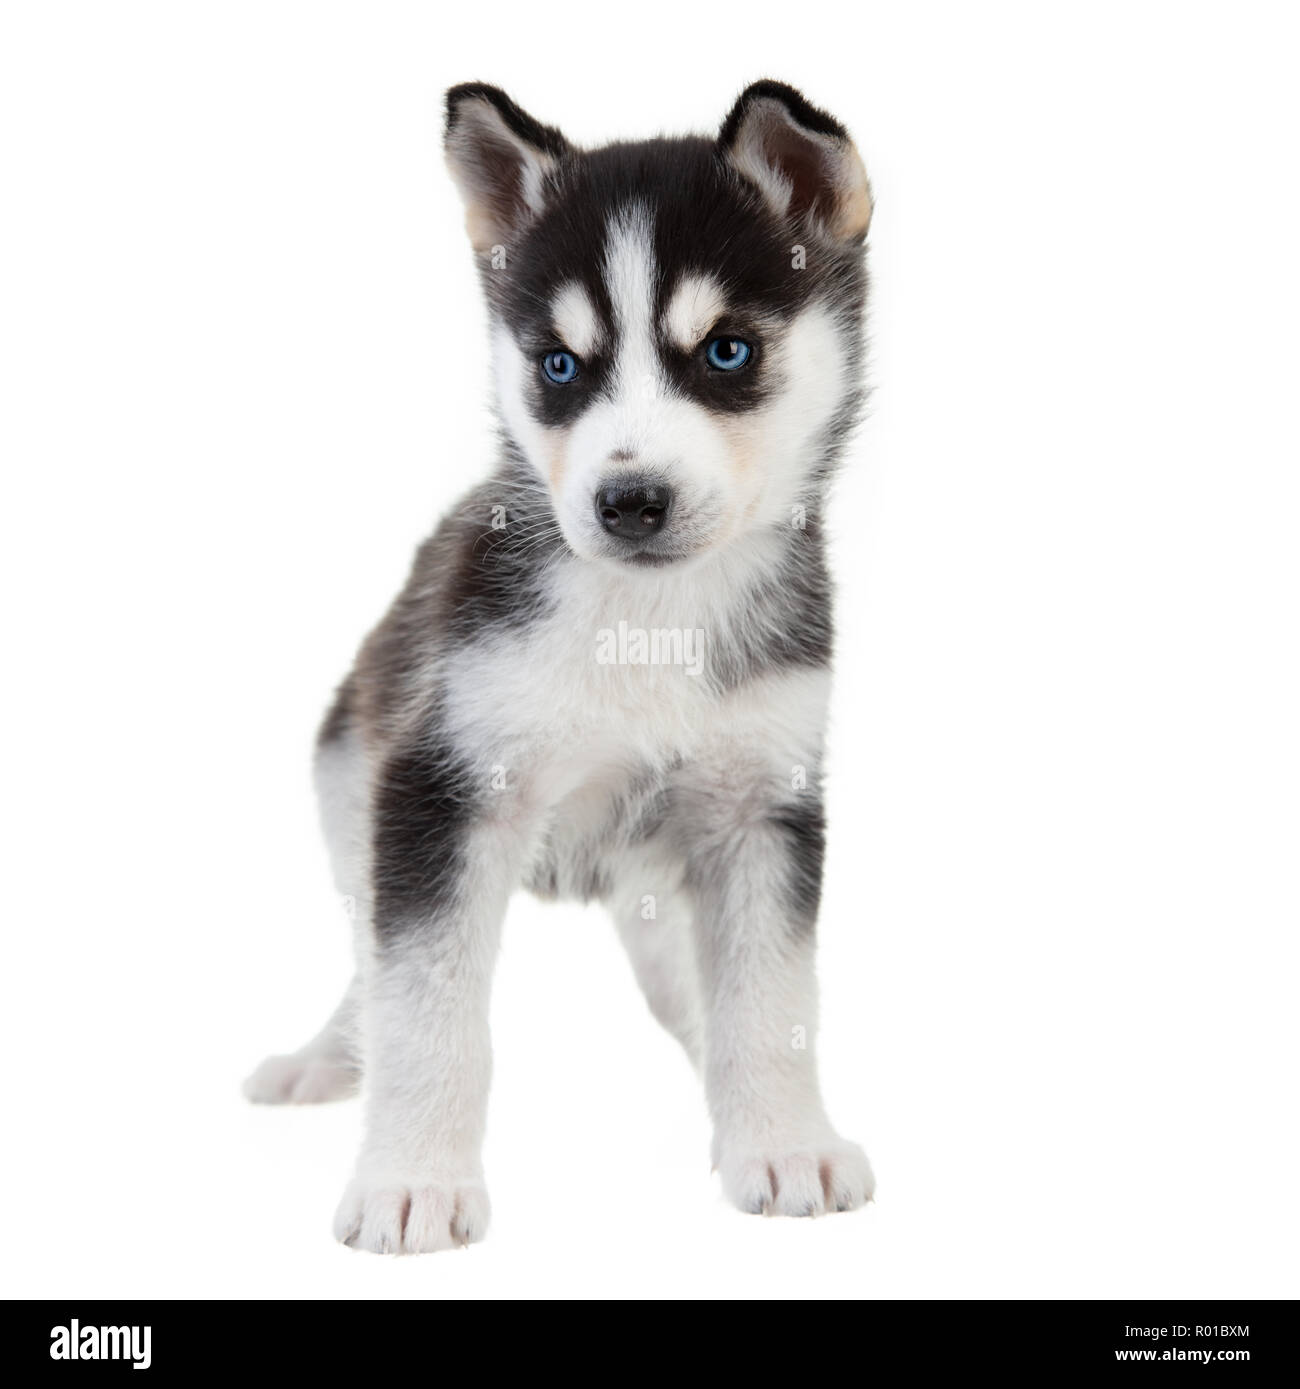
[689,775,874,1215]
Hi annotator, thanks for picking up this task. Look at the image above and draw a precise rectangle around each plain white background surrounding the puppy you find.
[0,0,1300,1297]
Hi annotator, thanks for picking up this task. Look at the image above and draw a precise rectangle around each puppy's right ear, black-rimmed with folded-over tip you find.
[718,82,871,242]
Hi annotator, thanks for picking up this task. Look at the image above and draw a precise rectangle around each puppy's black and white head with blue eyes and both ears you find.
[447,83,871,567]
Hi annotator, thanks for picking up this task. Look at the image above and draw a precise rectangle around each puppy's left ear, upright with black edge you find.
[443,82,571,251]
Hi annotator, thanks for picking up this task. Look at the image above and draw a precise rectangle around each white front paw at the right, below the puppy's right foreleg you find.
[718,1135,875,1215]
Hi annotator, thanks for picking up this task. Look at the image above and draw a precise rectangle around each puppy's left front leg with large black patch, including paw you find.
[335,749,518,1254]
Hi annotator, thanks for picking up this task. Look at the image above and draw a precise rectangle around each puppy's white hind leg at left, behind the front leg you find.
[243,683,371,1104]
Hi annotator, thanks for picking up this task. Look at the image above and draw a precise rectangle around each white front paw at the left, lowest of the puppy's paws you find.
[335,1178,492,1254]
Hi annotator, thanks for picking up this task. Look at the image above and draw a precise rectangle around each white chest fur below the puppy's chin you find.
[443,550,829,811]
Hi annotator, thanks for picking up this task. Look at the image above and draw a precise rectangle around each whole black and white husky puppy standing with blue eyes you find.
[246,82,872,1253]
